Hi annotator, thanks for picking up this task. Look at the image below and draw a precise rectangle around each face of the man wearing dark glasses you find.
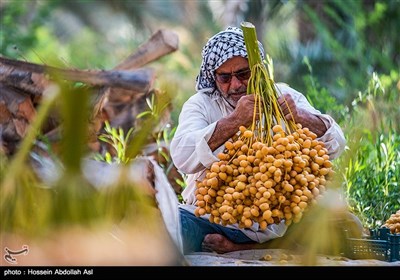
[215,56,251,107]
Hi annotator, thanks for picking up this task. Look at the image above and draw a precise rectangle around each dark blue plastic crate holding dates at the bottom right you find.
[345,228,400,262]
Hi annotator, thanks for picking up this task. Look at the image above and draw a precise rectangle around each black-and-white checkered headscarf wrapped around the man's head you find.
[196,27,264,94]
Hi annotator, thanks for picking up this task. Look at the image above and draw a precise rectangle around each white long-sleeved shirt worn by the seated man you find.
[170,84,346,242]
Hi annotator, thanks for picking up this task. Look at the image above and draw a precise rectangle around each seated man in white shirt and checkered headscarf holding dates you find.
[170,27,352,253]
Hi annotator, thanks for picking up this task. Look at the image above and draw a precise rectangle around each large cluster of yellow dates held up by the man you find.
[195,124,333,229]
